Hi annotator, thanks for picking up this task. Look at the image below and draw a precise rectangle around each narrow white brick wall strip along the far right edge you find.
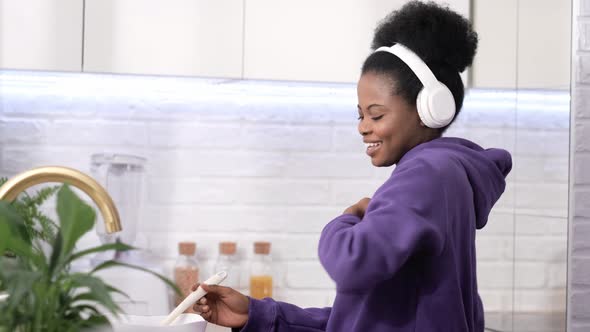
[567,0,590,332]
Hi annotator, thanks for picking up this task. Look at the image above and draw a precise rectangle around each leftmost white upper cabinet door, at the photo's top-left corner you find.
[0,0,83,71]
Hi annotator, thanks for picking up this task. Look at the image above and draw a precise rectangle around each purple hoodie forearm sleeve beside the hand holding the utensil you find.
[234,298,331,332]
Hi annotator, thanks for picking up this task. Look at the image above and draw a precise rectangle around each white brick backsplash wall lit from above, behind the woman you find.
[0,72,572,311]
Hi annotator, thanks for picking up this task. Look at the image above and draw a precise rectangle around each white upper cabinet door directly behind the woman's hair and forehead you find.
[244,0,469,83]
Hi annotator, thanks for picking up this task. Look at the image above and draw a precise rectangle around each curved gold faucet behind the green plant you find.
[0,166,121,233]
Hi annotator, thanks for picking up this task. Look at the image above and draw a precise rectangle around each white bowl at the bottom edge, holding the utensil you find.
[113,314,207,332]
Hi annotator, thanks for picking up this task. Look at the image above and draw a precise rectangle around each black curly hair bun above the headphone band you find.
[372,1,477,72]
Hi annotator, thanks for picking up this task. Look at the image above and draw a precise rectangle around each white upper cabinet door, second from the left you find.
[84,0,243,77]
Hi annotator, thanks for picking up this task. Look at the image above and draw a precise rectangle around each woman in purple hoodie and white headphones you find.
[194,2,512,332]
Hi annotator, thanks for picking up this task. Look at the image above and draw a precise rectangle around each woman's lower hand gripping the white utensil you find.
[192,284,250,328]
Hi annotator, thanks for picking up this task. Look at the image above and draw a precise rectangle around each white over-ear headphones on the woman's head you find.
[375,44,455,128]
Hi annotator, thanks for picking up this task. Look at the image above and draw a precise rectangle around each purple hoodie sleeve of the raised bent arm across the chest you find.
[318,159,449,291]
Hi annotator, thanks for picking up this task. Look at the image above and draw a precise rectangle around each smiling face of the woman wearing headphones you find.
[357,72,437,167]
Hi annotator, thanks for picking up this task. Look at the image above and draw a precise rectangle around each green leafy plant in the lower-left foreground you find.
[0,185,180,332]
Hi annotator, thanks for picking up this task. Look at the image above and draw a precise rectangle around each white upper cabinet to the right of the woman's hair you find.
[472,0,571,89]
